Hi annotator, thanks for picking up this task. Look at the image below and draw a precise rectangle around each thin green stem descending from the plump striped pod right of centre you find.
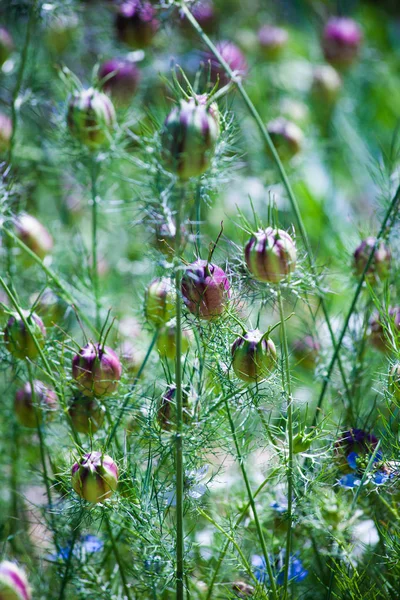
[278,289,294,598]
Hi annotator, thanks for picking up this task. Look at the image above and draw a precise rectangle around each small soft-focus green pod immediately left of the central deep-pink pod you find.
[145,277,175,327]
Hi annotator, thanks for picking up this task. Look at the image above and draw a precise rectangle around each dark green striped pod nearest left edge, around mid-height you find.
[4,310,46,360]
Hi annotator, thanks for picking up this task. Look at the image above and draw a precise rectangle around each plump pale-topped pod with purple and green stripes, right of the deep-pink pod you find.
[244,227,297,283]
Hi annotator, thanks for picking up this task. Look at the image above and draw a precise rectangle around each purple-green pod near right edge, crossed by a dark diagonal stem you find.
[354,237,392,285]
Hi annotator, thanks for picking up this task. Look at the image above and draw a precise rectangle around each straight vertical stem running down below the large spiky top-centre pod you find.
[175,185,186,600]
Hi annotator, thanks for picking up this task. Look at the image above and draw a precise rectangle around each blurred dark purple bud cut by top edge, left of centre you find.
[115,0,159,49]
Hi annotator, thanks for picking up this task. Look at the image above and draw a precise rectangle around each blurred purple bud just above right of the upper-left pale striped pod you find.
[98,58,140,106]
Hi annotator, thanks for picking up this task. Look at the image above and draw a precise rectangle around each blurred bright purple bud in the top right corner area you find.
[322,17,362,67]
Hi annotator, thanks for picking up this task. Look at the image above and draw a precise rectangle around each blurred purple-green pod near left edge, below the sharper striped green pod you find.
[14,380,58,429]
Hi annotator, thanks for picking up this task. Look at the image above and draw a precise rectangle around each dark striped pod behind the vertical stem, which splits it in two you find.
[157,384,200,431]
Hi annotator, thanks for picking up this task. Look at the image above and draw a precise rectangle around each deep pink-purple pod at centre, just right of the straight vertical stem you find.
[181,259,230,321]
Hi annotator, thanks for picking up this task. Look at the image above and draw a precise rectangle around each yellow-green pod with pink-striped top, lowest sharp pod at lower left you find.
[72,452,118,504]
